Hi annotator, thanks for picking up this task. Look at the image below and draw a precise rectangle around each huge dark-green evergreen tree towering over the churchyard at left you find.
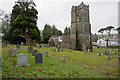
[6,2,40,45]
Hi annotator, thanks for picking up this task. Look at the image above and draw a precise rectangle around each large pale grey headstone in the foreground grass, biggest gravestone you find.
[17,53,30,66]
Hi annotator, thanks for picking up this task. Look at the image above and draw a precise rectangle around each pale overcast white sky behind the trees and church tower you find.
[0,0,119,34]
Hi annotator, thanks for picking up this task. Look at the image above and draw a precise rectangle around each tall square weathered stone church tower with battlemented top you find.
[70,2,92,51]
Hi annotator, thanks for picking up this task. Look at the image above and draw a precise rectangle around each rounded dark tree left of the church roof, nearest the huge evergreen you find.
[43,24,52,43]
